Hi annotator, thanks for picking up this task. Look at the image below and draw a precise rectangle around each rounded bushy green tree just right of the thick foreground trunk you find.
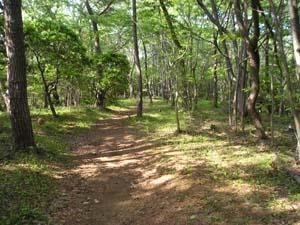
[26,18,88,117]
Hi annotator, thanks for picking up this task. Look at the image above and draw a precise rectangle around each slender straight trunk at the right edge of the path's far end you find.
[132,0,143,117]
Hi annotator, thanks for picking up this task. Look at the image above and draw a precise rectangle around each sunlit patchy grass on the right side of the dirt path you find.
[127,101,300,224]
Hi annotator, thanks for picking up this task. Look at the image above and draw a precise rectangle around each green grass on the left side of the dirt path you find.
[0,108,112,225]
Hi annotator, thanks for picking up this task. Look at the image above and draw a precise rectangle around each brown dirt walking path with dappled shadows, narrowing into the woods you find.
[54,108,186,225]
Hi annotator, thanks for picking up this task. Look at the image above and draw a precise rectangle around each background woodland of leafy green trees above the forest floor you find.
[0,0,300,160]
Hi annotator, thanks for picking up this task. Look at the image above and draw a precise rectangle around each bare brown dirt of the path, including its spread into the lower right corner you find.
[52,112,299,225]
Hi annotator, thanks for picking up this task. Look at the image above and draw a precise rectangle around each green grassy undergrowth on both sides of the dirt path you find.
[0,99,300,225]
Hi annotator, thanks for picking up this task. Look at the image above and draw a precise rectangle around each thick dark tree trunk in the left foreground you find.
[3,0,35,149]
